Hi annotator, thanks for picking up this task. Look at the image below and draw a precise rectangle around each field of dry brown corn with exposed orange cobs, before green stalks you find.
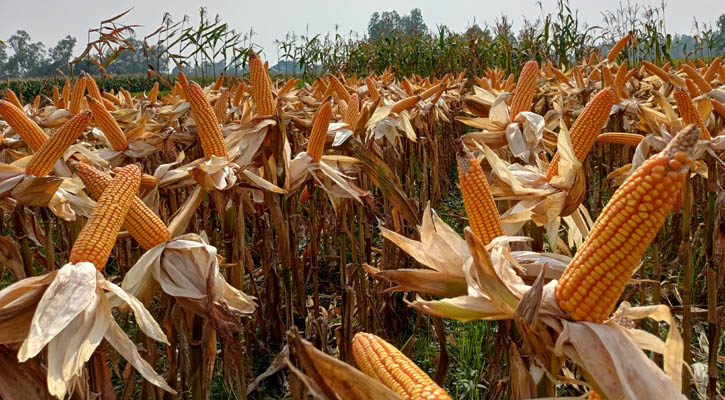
[0,21,725,400]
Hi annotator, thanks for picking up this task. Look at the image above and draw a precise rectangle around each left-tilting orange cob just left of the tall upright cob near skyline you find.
[182,81,229,160]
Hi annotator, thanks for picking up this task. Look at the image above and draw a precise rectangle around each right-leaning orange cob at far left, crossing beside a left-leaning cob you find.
[25,110,91,176]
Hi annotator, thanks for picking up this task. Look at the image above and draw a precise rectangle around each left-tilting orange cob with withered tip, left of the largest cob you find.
[456,140,504,244]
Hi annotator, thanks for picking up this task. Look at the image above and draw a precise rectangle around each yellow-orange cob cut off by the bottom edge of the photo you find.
[352,332,451,400]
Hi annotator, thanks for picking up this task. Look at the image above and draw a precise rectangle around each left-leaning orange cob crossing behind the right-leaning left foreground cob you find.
[75,162,171,250]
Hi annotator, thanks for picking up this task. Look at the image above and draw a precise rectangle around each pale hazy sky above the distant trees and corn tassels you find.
[0,0,725,61]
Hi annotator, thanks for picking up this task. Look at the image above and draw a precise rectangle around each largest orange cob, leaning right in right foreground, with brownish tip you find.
[555,125,700,322]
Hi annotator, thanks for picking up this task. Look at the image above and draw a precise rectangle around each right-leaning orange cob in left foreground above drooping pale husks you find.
[68,165,141,271]
